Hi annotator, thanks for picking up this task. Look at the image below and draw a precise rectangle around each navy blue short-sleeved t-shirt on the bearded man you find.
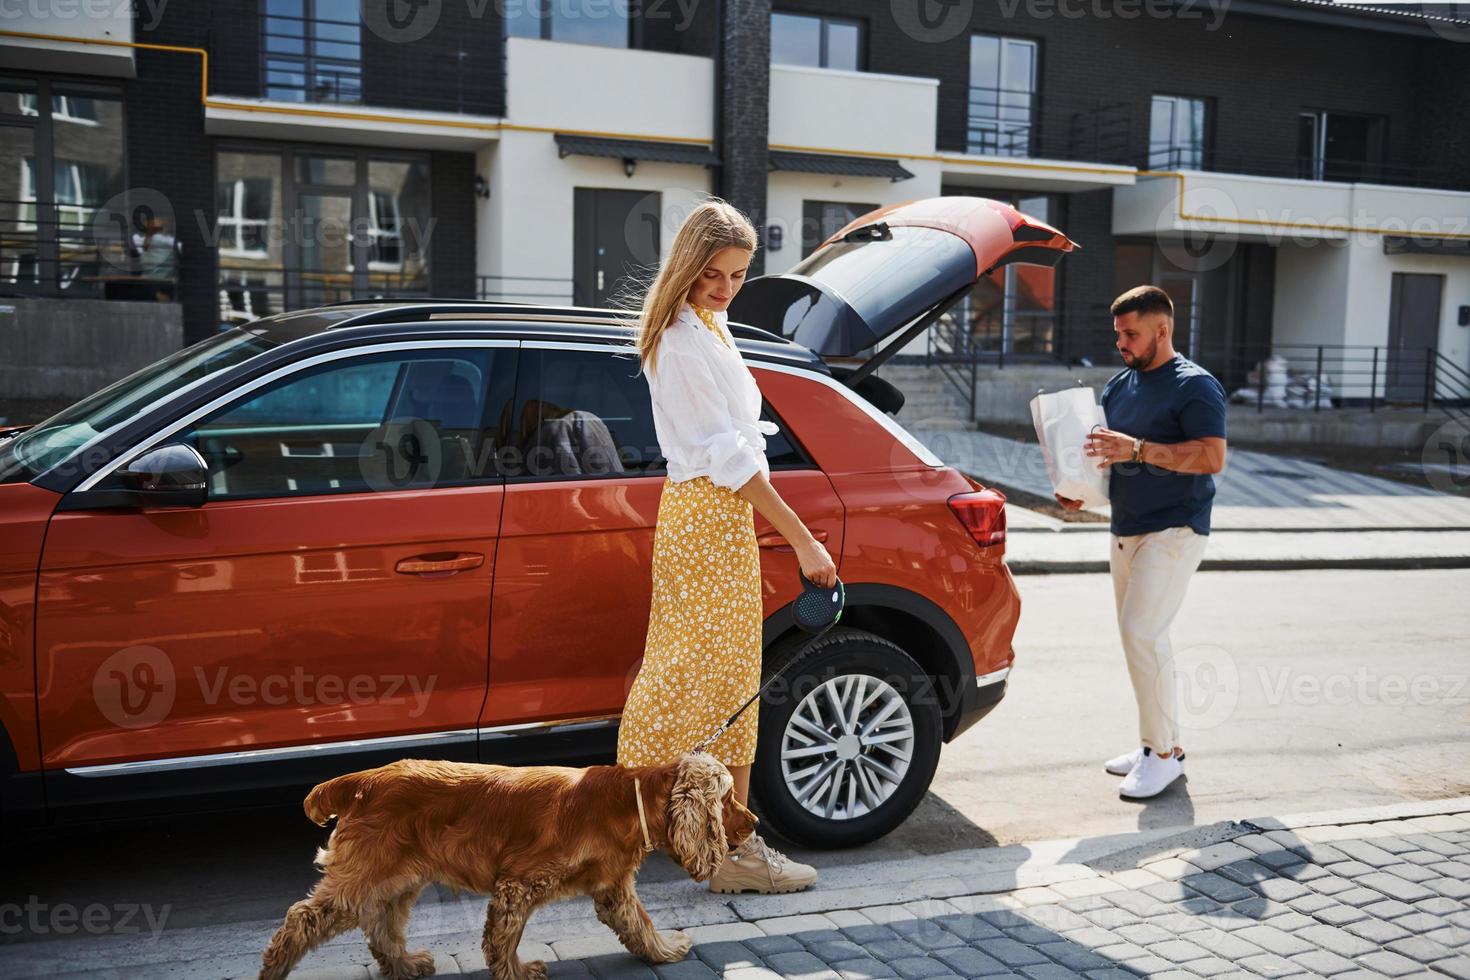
[1103,354,1225,536]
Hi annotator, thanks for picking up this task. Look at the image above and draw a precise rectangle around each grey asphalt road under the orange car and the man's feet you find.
[0,572,1470,962]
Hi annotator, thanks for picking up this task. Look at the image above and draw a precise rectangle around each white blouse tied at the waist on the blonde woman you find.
[645,303,781,489]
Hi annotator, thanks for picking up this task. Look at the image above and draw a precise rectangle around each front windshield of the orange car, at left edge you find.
[0,328,279,483]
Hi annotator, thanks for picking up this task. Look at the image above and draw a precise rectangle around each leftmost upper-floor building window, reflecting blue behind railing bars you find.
[260,0,363,103]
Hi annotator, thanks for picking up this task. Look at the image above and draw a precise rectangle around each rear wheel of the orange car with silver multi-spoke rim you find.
[751,630,942,848]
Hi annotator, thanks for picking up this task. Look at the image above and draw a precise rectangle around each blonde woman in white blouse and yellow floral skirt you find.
[617,198,836,893]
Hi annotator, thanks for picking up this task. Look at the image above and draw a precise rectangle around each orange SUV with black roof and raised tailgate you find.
[0,198,1073,846]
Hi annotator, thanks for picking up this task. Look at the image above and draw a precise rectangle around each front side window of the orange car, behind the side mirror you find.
[182,348,513,500]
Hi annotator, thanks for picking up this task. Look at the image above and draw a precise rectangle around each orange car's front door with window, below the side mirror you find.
[37,339,516,793]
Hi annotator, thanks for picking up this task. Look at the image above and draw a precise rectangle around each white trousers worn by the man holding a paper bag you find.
[1108,527,1210,752]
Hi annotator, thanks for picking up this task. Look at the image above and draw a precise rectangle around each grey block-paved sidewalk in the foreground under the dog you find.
[0,796,1470,980]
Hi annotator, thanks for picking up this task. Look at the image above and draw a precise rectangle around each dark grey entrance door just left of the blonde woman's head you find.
[572,187,663,307]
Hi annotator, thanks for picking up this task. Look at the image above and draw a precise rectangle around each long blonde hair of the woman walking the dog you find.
[635,197,760,370]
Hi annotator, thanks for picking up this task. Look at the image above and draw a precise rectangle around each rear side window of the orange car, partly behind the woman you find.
[500,348,810,479]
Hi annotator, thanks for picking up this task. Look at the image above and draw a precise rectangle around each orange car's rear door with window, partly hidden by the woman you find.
[482,341,842,760]
